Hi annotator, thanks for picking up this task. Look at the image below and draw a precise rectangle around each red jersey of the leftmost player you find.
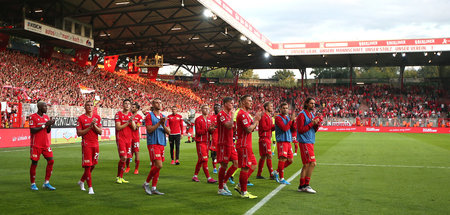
[30,113,50,148]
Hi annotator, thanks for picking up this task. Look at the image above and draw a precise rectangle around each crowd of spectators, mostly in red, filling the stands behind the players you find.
[0,50,450,127]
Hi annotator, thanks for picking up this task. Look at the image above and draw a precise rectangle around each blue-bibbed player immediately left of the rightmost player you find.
[273,102,294,185]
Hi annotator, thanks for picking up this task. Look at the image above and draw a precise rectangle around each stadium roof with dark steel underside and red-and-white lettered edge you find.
[0,0,450,69]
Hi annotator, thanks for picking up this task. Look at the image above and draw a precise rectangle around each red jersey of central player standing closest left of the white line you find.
[236,109,253,149]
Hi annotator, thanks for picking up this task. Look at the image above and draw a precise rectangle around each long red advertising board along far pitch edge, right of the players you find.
[319,126,450,134]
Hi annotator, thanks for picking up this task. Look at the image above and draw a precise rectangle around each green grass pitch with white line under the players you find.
[0,132,450,215]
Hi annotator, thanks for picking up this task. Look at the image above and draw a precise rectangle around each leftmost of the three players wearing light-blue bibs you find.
[143,98,170,195]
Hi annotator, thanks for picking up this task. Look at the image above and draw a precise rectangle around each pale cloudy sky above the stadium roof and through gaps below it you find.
[160,0,450,78]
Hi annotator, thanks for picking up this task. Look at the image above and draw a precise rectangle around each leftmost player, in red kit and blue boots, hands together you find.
[30,102,56,190]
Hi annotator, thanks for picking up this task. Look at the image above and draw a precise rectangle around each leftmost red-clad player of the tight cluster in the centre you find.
[192,105,217,183]
